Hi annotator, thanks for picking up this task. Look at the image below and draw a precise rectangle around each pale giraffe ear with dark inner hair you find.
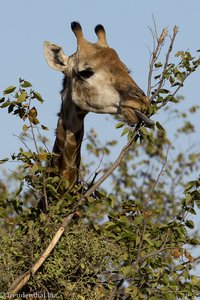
[44,41,68,72]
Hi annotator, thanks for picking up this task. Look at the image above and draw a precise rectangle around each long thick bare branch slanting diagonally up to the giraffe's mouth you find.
[8,125,140,295]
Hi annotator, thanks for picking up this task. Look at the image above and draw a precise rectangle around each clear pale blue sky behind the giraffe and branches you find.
[0,0,200,166]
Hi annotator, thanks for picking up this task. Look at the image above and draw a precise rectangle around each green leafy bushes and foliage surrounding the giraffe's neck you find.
[0,27,200,300]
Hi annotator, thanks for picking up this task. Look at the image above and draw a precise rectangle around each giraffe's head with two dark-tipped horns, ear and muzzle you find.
[44,22,149,125]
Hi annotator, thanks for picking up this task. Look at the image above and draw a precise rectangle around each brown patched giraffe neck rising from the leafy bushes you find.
[53,80,86,189]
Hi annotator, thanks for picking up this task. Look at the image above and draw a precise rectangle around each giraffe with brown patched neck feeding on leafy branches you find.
[44,22,149,189]
